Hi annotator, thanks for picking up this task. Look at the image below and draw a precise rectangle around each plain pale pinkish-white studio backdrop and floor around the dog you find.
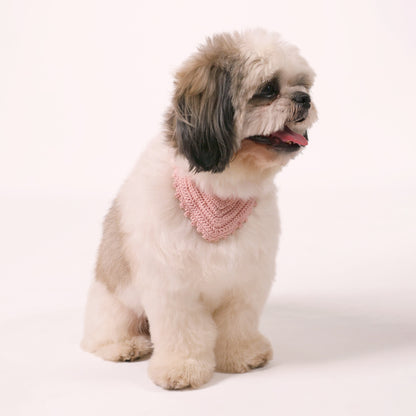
[0,0,416,416]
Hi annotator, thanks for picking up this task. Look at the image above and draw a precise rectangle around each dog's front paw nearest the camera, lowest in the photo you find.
[149,357,215,390]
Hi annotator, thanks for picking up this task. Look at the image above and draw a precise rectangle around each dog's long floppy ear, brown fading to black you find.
[173,65,235,173]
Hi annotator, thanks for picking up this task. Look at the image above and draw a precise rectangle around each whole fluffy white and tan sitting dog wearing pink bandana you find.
[82,30,317,389]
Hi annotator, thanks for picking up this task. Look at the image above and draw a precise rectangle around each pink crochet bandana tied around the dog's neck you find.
[173,170,256,242]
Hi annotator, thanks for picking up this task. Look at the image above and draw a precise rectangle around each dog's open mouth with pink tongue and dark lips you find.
[247,126,308,152]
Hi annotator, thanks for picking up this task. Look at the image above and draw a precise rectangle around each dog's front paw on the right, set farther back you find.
[215,334,273,373]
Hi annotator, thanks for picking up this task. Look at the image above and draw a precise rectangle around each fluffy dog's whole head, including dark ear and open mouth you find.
[166,30,317,173]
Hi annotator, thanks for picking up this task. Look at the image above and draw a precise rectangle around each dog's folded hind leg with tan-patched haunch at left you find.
[81,200,152,361]
